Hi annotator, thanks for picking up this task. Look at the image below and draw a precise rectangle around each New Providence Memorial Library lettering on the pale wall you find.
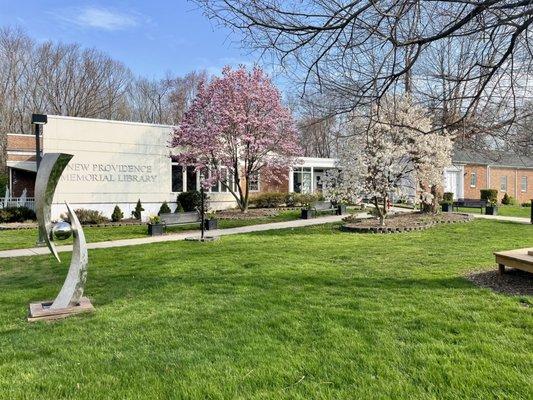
[61,163,157,183]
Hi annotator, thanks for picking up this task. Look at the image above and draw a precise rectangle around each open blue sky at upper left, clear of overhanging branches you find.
[0,0,256,78]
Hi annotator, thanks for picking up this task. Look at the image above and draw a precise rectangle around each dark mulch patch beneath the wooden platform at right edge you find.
[466,267,533,298]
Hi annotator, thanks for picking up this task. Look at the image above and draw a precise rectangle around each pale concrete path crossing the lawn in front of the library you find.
[0,215,346,258]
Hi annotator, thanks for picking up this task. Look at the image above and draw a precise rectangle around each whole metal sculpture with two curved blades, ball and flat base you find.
[28,153,93,321]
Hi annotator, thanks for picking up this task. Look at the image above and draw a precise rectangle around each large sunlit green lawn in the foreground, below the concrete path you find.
[0,220,533,400]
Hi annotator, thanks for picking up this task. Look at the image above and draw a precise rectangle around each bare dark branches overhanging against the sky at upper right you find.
[197,0,533,152]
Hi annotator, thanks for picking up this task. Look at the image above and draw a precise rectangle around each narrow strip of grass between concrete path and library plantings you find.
[0,210,300,251]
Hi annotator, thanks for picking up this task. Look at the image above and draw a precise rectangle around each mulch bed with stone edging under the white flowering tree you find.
[341,212,473,233]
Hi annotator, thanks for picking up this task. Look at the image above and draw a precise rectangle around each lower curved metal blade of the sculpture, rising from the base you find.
[50,203,89,309]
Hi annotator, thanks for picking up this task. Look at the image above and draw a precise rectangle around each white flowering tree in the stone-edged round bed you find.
[325,96,452,225]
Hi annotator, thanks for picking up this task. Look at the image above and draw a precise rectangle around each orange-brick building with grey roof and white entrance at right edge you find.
[444,150,533,203]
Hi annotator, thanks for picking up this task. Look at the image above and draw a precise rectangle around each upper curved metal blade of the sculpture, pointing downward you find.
[35,153,74,262]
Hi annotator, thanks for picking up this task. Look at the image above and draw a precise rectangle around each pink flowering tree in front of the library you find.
[171,67,300,211]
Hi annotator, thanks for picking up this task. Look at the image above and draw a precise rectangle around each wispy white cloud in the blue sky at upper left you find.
[55,7,140,31]
